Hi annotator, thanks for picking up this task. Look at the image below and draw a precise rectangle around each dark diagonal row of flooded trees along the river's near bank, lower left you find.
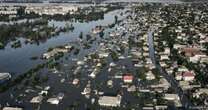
[0,43,64,92]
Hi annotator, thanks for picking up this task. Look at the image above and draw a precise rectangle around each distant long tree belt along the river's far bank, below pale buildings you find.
[0,5,124,22]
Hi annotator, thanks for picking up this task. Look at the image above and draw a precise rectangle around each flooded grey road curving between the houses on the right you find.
[148,28,191,110]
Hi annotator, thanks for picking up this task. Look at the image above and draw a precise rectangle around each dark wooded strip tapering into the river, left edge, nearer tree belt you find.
[0,19,74,49]
